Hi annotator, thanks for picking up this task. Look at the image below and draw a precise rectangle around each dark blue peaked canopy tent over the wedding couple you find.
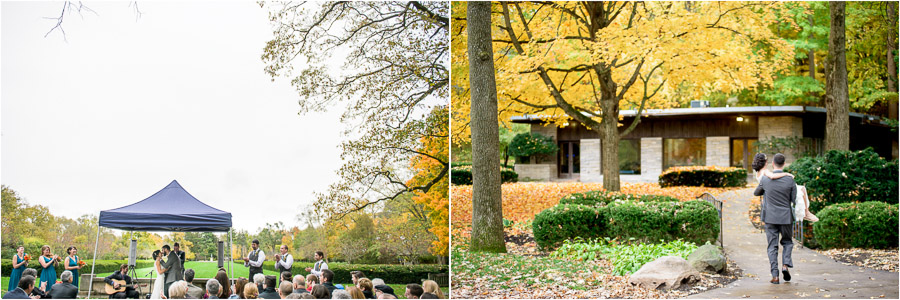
[88,180,234,297]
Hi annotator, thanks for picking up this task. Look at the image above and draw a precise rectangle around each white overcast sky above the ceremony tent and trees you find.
[0,1,343,231]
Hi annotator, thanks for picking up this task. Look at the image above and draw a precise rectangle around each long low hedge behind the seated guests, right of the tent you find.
[263,261,449,284]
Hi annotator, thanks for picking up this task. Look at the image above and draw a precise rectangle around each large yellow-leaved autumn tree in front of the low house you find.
[451,1,796,191]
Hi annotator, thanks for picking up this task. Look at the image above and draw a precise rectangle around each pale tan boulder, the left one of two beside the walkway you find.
[628,256,700,289]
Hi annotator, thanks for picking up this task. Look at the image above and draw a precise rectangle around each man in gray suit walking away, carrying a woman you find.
[753,153,797,284]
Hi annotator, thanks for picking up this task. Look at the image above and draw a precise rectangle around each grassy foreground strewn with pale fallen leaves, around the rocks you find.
[452,236,741,299]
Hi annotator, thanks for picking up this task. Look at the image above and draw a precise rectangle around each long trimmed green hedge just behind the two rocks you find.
[533,200,719,249]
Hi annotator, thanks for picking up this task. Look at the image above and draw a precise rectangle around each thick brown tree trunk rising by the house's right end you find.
[825,2,850,151]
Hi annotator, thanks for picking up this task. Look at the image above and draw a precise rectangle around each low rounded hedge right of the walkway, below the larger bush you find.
[813,201,900,249]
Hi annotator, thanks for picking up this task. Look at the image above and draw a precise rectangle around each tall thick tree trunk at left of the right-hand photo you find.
[466,1,506,253]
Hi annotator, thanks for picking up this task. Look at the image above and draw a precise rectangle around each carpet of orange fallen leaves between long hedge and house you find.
[450,182,739,240]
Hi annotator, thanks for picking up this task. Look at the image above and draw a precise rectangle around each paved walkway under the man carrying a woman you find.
[689,189,900,299]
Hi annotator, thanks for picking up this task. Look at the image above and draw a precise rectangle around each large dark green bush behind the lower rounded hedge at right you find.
[785,148,900,212]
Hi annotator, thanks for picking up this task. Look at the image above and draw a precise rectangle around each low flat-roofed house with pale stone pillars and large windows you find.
[512,106,898,182]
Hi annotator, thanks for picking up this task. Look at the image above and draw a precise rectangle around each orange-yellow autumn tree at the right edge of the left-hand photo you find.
[407,106,450,256]
